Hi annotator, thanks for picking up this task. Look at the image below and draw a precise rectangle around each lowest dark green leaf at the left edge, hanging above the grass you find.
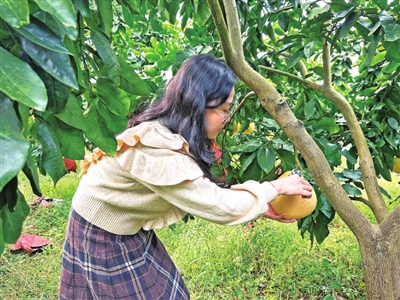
[0,190,30,254]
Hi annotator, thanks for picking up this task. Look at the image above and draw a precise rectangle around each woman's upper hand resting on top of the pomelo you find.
[270,174,312,198]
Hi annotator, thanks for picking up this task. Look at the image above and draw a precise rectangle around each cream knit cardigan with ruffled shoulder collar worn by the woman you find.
[72,121,277,235]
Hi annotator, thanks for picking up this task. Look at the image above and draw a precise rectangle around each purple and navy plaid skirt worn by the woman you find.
[59,210,190,300]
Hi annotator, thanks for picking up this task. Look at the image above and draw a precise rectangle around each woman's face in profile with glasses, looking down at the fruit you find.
[206,88,235,139]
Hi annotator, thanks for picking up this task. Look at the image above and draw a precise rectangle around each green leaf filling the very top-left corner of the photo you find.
[0,0,29,28]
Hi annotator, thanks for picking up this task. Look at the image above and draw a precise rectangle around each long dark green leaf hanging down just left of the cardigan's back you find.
[37,121,68,184]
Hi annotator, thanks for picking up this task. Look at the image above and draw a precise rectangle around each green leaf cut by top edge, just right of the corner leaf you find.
[33,0,78,40]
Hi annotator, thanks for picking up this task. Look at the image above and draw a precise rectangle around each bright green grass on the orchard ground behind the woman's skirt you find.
[0,173,399,300]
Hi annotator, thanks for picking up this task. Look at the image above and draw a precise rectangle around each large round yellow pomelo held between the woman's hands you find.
[271,171,317,219]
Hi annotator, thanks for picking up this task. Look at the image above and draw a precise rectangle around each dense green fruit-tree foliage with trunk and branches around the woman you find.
[0,0,400,300]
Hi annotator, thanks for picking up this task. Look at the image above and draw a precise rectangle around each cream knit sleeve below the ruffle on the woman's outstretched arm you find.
[138,177,277,225]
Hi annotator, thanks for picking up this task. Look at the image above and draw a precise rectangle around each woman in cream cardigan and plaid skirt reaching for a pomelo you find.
[60,54,311,300]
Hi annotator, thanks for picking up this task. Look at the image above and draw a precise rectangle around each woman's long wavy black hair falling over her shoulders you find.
[128,54,237,179]
